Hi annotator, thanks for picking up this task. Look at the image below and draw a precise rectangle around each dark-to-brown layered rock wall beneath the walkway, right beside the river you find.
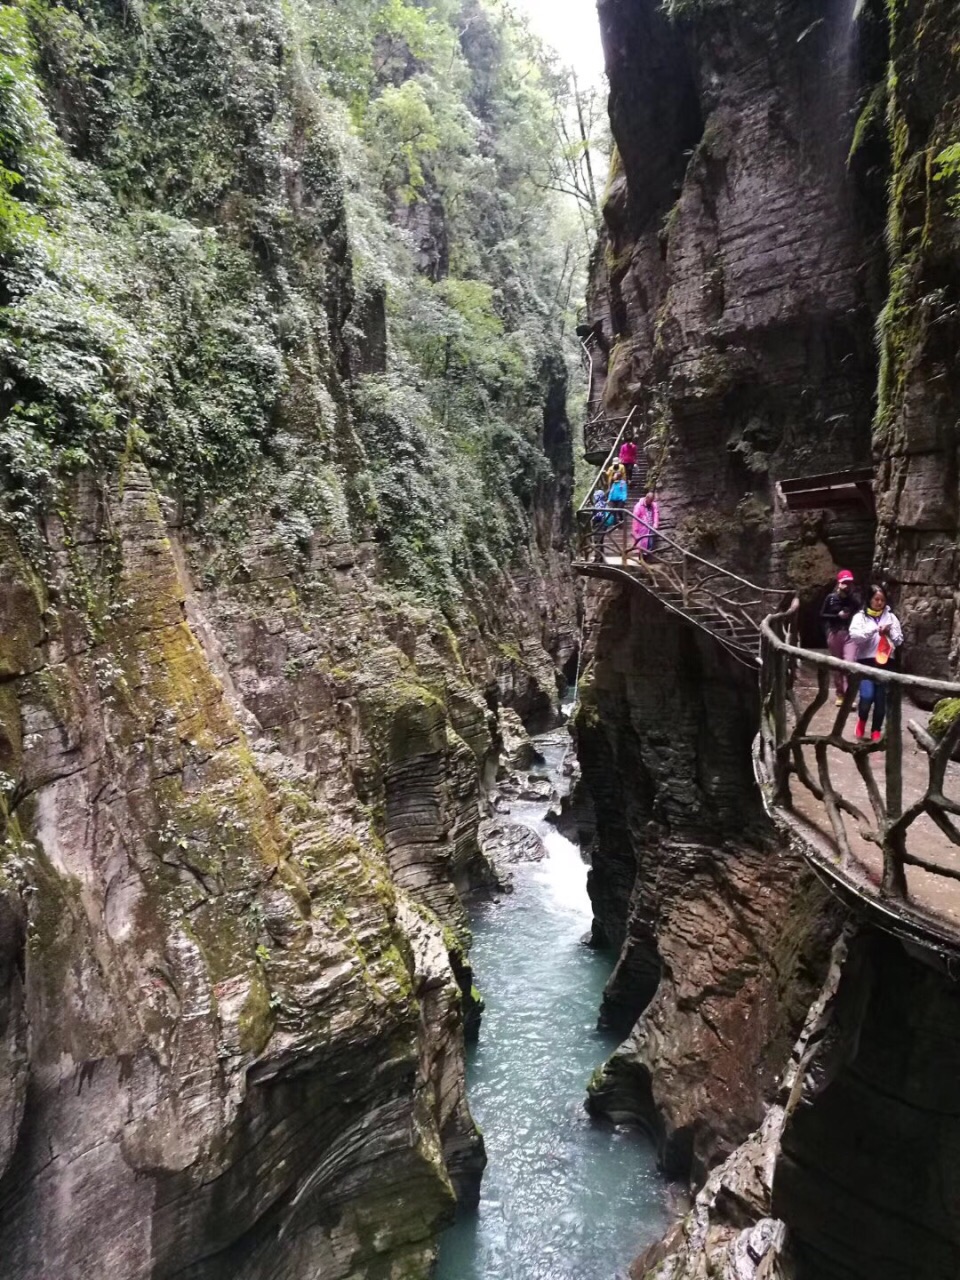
[576,589,837,1184]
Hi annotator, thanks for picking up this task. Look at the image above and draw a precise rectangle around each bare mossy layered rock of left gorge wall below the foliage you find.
[0,455,572,1280]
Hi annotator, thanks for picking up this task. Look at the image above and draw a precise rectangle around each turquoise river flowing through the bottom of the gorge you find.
[435,733,667,1280]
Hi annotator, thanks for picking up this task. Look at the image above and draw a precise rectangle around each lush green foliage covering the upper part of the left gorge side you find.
[0,0,586,603]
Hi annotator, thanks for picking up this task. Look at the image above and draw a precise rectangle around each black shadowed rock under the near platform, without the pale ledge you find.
[772,931,960,1280]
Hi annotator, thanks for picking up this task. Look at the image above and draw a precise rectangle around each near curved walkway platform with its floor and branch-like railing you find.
[754,605,960,956]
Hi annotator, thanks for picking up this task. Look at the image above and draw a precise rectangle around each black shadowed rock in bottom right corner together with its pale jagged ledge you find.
[632,928,960,1280]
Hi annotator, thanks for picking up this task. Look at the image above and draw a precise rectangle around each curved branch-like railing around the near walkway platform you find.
[756,600,960,901]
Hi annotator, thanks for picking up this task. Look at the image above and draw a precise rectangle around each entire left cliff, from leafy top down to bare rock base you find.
[0,0,575,1280]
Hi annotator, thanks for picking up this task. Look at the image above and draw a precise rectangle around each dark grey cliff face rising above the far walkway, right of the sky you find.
[591,0,882,586]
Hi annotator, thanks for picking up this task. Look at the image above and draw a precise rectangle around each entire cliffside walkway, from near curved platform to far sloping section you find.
[575,420,960,964]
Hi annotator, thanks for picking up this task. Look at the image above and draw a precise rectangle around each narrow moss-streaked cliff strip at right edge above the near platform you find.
[877,3,960,680]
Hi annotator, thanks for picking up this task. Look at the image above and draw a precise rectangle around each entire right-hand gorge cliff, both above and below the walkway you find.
[579,0,960,1280]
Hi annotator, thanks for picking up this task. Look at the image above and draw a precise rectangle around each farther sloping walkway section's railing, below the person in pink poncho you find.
[577,499,790,663]
